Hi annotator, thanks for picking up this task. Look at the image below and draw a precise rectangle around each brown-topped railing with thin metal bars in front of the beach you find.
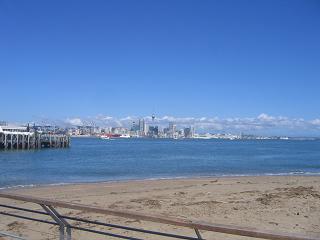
[0,193,320,240]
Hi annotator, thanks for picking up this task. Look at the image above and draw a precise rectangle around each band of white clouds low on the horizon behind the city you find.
[1,113,320,137]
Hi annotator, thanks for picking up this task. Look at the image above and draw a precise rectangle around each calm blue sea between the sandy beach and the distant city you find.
[0,138,320,188]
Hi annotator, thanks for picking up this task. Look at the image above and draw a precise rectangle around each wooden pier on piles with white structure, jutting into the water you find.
[0,126,70,150]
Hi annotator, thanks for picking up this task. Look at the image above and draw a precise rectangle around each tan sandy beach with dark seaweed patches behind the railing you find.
[0,176,320,239]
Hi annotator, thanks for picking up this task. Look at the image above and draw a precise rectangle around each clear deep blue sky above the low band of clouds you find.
[0,0,320,121]
